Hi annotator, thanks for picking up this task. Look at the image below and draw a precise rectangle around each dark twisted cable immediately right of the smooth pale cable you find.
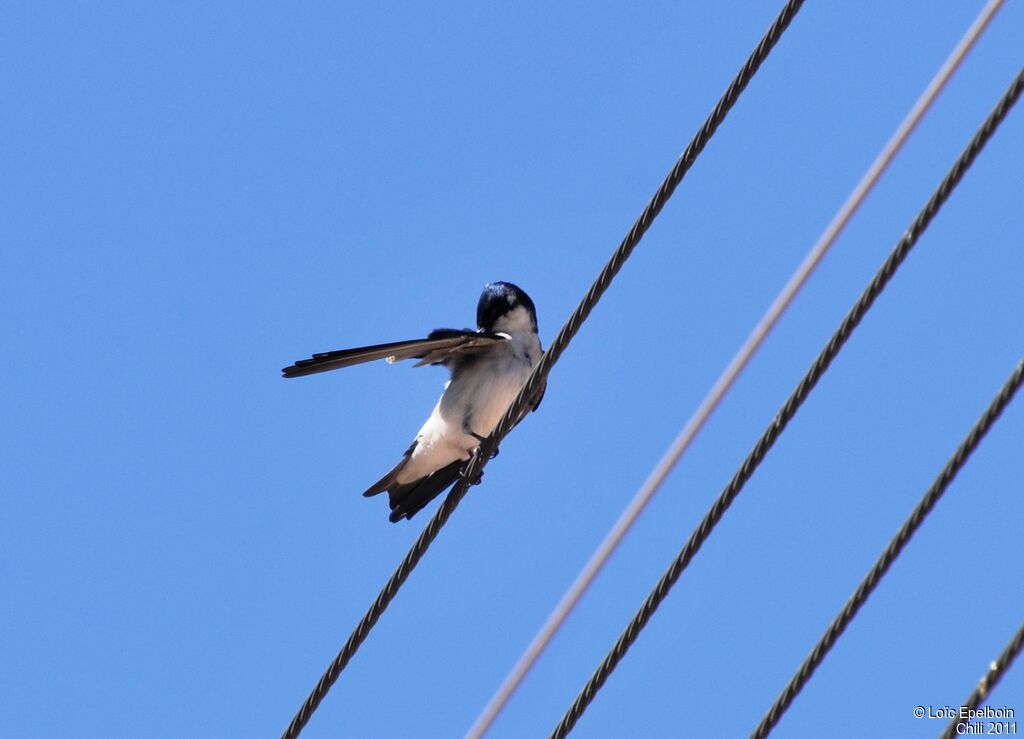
[551,70,1024,739]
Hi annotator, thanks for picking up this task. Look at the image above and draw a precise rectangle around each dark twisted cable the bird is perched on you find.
[282,0,804,739]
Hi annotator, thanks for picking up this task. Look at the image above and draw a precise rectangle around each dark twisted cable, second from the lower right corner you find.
[751,360,1024,739]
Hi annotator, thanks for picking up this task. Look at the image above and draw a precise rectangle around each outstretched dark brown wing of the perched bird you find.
[281,329,508,378]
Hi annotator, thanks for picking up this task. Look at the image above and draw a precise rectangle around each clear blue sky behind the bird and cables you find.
[0,0,1024,737]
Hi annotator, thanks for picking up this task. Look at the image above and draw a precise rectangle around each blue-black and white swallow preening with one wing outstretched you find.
[282,281,545,523]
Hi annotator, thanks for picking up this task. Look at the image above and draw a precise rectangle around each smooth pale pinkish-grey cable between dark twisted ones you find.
[466,0,1004,739]
